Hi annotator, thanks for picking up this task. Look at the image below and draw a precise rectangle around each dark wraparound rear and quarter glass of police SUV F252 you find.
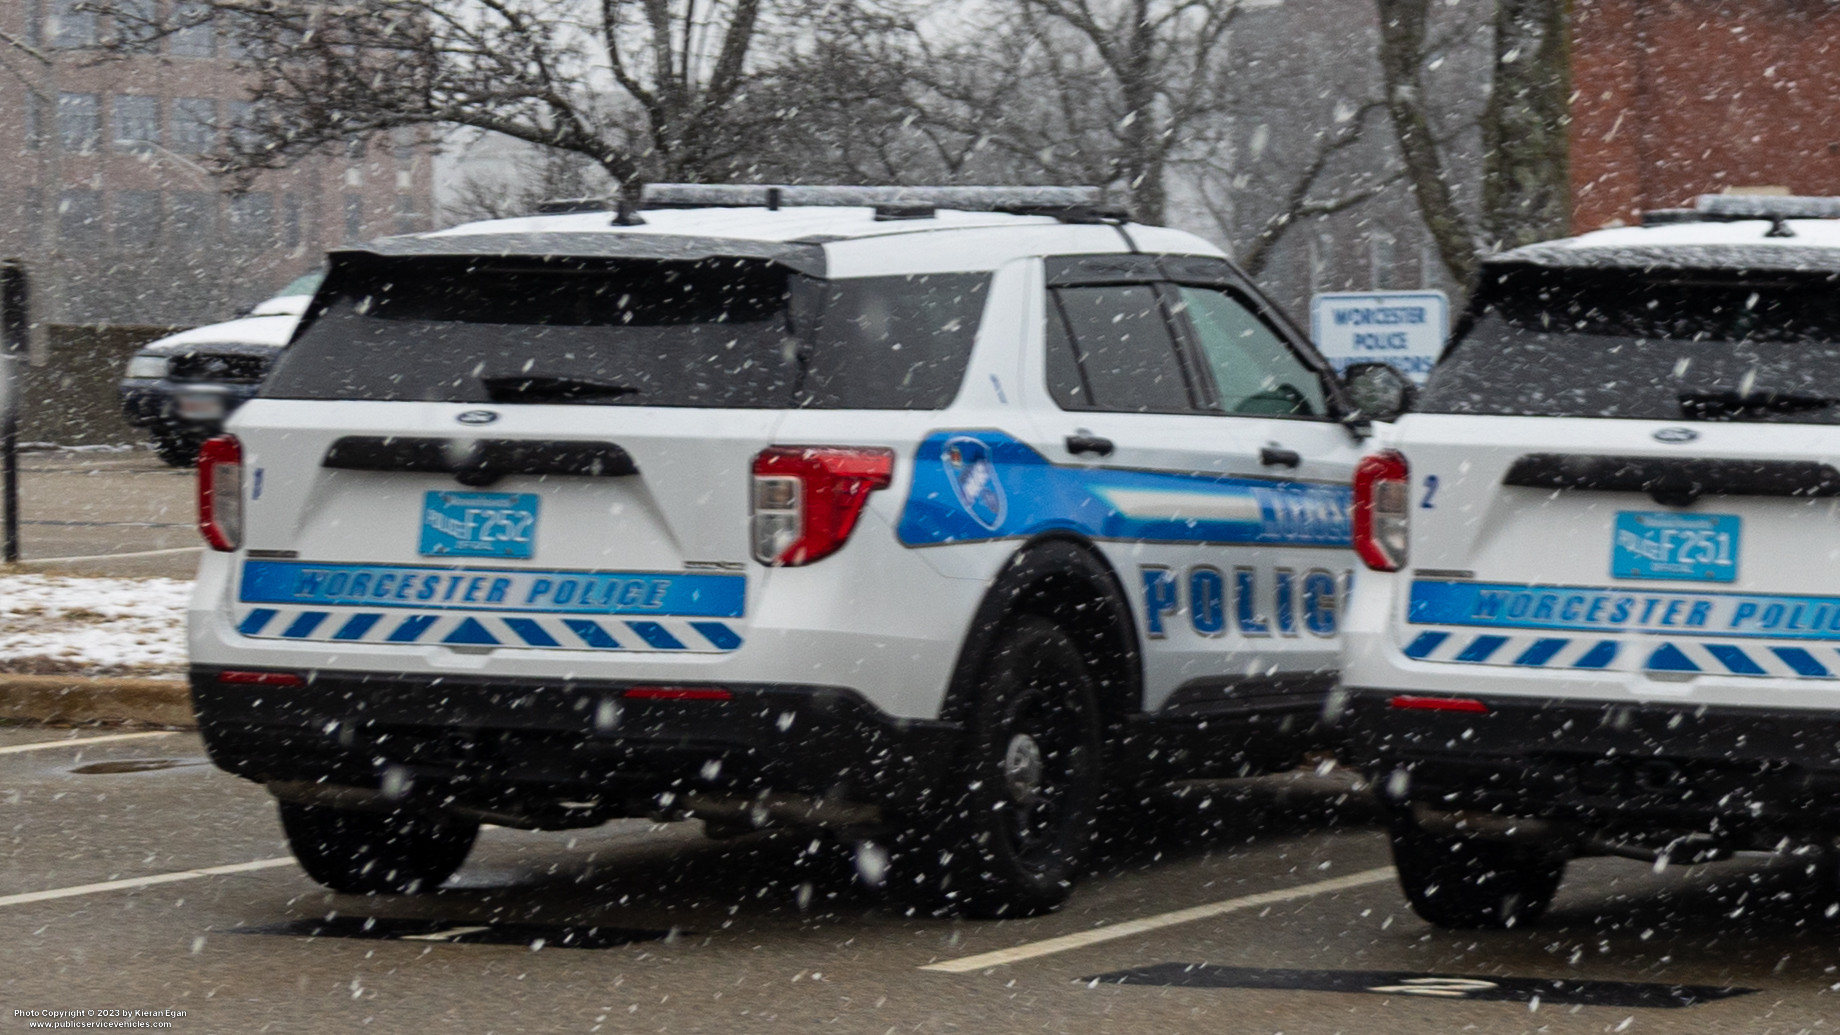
[261,258,990,409]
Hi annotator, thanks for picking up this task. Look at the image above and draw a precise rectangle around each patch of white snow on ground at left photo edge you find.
[0,575,191,676]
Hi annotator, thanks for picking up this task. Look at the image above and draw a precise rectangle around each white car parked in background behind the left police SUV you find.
[121,271,324,468]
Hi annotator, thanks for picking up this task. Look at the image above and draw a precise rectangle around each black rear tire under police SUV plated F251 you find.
[1393,814,1566,930]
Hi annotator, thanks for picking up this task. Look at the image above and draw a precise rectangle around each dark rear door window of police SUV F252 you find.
[1047,284,1194,413]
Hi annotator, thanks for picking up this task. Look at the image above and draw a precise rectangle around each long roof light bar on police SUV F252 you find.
[638,184,1104,212]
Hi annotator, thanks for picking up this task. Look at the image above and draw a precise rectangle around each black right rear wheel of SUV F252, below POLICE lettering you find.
[891,615,1102,917]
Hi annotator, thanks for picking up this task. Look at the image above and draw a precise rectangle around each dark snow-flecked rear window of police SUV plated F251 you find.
[1417,265,1840,424]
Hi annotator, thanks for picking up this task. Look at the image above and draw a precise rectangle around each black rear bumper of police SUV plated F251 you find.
[1340,689,1840,845]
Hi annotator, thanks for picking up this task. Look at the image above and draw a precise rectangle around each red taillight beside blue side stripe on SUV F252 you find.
[753,446,894,567]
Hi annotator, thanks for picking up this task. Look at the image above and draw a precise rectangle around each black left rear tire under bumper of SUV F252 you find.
[280,801,478,895]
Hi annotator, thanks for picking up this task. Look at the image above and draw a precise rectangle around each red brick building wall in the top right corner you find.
[1571,0,1840,232]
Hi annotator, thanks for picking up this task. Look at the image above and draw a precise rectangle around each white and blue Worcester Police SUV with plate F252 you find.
[191,186,1400,915]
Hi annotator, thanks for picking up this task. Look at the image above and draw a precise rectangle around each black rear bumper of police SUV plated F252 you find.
[191,665,957,818]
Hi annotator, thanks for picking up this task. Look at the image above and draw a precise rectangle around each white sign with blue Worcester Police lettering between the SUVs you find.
[1310,291,1450,385]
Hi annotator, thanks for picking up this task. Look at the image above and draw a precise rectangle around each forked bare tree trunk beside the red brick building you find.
[1376,0,1571,284]
